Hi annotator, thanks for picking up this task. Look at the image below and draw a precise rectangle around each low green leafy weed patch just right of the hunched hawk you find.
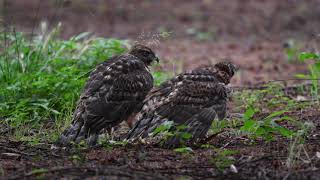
[232,83,301,140]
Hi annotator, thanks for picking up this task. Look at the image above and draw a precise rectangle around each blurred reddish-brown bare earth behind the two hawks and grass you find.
[1,0,320,84]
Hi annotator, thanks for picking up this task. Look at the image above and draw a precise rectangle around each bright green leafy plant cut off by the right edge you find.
[296,52,320,100]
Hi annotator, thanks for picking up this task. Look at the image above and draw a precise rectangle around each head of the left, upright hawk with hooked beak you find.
[129,44,159,66]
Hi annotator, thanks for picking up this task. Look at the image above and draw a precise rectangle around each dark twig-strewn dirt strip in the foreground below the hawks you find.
[0,105,320,179]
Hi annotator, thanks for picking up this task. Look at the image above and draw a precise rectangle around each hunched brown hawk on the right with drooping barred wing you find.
[126,62,236,147]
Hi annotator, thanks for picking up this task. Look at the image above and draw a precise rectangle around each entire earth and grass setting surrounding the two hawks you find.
[0,0,320,179]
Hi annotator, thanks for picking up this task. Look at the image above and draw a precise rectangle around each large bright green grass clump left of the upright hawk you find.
[0,27,126,142]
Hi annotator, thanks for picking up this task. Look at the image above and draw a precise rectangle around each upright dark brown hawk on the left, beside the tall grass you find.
[58,45,159,145]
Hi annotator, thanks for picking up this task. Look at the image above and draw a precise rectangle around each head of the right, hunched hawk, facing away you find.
[214,62,237,84]
